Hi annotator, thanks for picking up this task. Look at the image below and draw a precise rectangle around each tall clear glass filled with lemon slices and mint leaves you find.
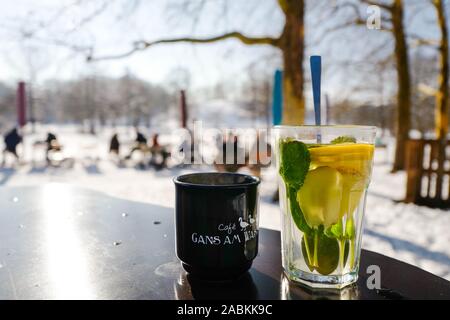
[274,126,376,288]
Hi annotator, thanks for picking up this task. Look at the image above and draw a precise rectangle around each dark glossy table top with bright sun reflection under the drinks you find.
[0,184,450,299]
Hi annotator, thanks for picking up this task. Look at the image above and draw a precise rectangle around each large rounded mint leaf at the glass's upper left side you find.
[279,140,311,191]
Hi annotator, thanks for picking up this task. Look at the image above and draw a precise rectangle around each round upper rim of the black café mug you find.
[173,172,261,189]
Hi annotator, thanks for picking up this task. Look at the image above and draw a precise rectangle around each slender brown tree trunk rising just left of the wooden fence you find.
[392,0,411,172]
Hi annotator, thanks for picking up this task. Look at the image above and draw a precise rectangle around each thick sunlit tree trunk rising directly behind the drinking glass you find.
[279,0,305,125]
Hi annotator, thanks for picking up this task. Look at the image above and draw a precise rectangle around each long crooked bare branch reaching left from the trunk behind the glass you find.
[87,31,279,61]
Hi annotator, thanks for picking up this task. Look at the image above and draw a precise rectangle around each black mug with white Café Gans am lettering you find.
[174,172,260,281]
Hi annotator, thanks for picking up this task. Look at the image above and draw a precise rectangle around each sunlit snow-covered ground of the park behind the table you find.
[0,126,450,280]
